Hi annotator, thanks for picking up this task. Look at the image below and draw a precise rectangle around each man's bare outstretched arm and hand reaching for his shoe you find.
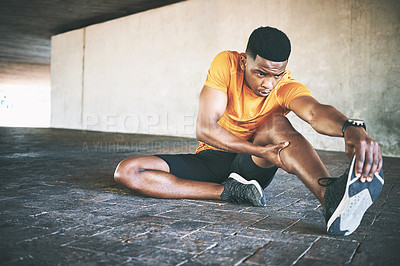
[289,96,383,182]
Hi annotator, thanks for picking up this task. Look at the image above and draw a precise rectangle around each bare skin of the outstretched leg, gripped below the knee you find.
[252,116,330,205]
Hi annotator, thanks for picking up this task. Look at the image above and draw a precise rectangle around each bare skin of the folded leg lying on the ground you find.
[114,156,224,199]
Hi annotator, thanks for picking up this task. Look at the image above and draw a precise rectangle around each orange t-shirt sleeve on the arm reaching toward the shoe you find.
[276,82,312,111]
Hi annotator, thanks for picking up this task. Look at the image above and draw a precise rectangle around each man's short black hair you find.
[246,27,291,62]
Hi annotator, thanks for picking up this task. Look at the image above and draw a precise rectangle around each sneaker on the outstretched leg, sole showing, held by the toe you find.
[318,156,384,236]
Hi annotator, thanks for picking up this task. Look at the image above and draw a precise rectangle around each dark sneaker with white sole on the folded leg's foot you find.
[221,173,267,207]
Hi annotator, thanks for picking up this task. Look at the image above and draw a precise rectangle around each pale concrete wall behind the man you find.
[51,0,400,156]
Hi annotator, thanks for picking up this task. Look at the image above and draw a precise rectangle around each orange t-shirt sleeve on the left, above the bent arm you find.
[204,52,231,92]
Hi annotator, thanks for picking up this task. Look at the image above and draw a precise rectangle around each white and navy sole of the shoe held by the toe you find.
[327,156,384,236]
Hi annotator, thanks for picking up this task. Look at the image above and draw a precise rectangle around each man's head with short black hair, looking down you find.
[241,27,291,97]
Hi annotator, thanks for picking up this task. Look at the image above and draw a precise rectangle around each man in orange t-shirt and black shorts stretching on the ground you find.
[114,27,383,235]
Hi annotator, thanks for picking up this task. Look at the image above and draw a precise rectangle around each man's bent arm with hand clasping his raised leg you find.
[196,86,287,169]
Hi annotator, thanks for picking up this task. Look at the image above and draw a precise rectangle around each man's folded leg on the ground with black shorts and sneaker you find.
[114,151,266,206]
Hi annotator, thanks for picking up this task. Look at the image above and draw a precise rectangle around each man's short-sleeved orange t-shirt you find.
[196,51,312,153]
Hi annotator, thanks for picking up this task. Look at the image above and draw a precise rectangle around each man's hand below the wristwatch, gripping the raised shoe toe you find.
[344,126,383,182]
